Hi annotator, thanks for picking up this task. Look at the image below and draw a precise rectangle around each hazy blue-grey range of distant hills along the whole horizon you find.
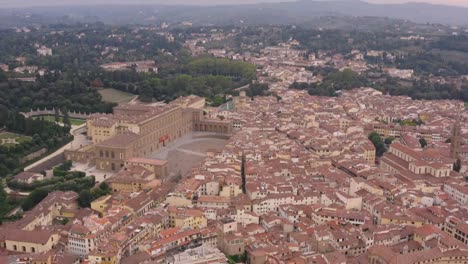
[0,0,468,26]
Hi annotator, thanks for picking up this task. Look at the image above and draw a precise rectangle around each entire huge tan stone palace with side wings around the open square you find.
[65,96,232,172]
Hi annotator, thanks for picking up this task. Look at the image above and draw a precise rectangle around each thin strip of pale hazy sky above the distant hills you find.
[0,0,468,8]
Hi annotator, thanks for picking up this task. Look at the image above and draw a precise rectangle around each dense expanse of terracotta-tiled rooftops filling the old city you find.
[0,32,468,264]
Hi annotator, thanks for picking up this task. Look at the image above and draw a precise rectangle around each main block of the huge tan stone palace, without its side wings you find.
[79,104,193,174]
